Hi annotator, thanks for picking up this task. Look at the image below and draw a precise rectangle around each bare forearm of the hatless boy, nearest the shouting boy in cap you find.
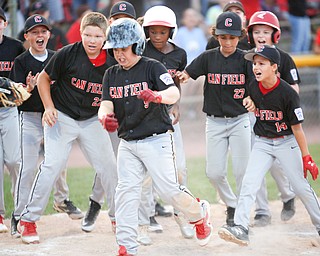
[37,71,54,109]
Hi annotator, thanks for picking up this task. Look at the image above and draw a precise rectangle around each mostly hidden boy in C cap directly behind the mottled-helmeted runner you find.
[81,1,136,232]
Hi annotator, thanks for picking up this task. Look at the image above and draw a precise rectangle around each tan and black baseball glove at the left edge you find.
[0,77,31,107]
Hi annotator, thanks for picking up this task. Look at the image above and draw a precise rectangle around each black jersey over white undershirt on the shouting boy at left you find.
[10,49,55,112]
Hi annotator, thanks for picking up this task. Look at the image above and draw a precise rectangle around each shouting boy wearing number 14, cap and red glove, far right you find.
[219,45,320,245]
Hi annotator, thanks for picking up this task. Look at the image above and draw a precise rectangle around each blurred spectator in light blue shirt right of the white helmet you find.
[174,8,207,64]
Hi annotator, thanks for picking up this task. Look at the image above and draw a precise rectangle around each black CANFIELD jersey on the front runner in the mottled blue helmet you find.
[102,56,175,140]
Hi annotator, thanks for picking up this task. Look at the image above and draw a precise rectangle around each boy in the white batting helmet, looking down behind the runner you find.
[138,6,194,244]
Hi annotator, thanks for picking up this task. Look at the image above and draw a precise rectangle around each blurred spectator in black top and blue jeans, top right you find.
[288,0,311,54]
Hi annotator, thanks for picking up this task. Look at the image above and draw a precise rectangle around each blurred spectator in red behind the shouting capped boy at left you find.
[18,0,68,51]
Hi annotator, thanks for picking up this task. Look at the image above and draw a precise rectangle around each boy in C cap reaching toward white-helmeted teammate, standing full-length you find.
[177,12,252,225]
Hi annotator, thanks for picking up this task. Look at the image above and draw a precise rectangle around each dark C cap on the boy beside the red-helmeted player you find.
[215,12,242,36]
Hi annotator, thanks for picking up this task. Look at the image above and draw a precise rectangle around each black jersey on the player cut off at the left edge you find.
[0,36,25,77]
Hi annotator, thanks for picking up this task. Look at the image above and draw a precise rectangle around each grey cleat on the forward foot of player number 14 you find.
[218,225,249,246]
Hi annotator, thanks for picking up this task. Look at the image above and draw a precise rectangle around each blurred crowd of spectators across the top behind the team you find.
[1,0,320,55]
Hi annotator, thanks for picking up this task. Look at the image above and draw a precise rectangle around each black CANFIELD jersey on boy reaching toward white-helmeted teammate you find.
[186,48,253,117]
